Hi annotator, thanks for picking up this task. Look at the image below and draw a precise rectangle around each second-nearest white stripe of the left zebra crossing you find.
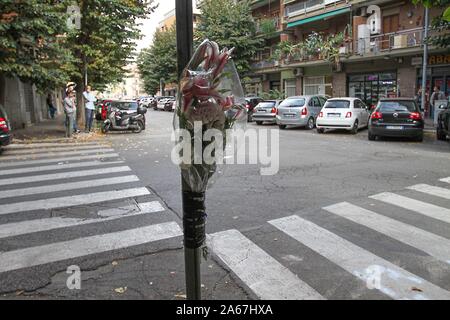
[0,201,165,239]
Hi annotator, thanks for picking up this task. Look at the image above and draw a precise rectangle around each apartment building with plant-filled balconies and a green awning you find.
[249,0,450,110]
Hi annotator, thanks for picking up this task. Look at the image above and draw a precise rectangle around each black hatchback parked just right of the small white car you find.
[369,98,425,142]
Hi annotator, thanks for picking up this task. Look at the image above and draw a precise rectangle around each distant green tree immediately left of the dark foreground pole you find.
[138,27,178,94]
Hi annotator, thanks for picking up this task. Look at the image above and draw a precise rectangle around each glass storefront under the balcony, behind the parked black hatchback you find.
[347,71,398,106]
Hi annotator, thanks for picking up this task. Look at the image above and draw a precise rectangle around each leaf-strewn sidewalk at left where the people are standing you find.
[13,115,103,143]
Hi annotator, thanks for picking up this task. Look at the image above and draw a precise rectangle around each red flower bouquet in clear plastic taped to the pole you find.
[174,40,247,248]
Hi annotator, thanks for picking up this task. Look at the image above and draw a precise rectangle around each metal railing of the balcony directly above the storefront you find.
[349,28,423,55]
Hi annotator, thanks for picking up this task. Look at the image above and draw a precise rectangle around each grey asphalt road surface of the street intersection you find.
[0,111,450,299]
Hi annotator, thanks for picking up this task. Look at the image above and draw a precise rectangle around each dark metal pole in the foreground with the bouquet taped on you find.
[175,0,201,300]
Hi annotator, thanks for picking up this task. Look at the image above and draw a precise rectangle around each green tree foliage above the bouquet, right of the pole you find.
[195,0,263,77]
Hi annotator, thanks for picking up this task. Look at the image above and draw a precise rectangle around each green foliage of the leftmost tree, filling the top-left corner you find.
[0,0,75,90]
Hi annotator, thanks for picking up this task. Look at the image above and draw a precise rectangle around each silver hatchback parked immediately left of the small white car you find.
[276,95,327,130]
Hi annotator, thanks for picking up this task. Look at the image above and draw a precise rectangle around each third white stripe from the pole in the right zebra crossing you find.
[324,202,450,264]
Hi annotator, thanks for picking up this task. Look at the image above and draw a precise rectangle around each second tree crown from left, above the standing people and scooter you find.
[68,0,155,89]
